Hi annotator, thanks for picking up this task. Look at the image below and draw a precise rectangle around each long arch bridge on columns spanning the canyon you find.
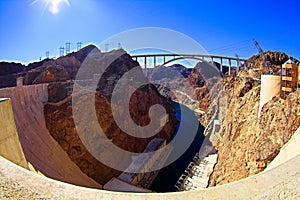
[131,54,247,75]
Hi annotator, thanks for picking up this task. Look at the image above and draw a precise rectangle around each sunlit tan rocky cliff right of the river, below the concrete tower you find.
[165,52,300,186]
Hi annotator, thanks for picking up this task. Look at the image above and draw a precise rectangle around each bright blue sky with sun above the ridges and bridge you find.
[0,0,300,63]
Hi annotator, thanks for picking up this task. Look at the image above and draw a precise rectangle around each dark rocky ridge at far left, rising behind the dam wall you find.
[0,45,96,88]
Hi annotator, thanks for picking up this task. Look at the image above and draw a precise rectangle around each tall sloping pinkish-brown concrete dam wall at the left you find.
[0,84,101,188]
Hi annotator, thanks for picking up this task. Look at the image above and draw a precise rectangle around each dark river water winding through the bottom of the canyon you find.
[149,102,205,192]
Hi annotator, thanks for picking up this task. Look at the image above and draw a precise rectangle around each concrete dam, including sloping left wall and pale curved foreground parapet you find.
[0,88,300,199]
